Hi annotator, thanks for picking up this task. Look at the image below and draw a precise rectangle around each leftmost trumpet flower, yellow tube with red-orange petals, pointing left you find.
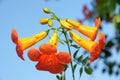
[11,29,47,60]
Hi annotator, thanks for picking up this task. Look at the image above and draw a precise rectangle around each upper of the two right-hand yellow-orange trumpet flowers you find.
[67,18,101,41]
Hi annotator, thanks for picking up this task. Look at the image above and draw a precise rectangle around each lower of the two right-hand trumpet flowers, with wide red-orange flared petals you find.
[70,32,105,63]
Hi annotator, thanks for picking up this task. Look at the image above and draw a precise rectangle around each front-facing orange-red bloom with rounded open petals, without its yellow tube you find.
[28,43,71,74]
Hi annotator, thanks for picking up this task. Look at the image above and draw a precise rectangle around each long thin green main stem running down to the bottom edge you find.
[63,29,75,80]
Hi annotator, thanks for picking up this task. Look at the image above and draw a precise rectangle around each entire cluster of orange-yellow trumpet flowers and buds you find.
[11,8,105,74]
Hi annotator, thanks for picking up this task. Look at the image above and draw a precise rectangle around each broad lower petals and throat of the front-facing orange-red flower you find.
[36,54,64,74]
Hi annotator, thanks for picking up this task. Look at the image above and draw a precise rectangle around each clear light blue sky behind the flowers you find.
[0,0,115,80]
